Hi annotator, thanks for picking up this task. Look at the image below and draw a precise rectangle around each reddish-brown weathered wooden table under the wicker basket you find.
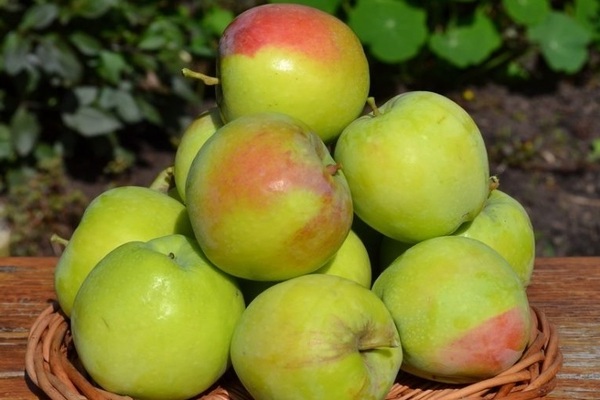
[0,257,600,399]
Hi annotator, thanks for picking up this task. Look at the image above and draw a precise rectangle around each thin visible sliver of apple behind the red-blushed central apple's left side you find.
[173,107,223,203]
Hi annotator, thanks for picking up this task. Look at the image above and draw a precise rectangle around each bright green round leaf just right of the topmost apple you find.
[348,0,428,63]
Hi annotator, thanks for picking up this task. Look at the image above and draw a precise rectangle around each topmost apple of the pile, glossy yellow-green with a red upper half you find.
[216,4,370,142]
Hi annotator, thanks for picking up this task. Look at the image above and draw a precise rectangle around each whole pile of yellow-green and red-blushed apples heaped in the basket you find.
[55,4,534,400]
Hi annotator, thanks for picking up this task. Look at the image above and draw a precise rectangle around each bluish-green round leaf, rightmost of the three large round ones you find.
[527,12,592,74]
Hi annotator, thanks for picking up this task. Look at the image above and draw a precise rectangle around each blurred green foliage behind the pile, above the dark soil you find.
[0,0,600,190]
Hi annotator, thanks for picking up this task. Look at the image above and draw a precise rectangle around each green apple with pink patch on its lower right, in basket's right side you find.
[372,236,531,383]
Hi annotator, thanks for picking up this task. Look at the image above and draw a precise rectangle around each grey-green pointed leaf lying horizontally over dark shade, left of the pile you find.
[62,106,123,137]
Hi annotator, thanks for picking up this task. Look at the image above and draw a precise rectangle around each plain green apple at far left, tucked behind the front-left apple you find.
[54,186,193,315]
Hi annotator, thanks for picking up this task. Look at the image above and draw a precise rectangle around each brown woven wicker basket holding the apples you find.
[25,303,562,400]
